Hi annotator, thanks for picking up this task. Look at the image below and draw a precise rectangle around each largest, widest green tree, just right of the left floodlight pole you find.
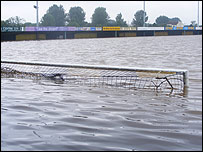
[41,4,67,26]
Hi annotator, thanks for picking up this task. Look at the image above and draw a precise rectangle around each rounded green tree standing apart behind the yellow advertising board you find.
[92,7,109,26]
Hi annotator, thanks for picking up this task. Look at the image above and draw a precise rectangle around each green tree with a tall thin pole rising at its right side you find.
[131,10,148,27]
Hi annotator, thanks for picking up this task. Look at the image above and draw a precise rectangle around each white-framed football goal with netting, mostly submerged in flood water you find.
[1,61,189,93]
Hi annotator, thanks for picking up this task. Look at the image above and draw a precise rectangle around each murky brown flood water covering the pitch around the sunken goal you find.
[1,35,202,151]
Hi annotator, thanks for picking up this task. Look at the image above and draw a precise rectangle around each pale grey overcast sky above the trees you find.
[1,1,202,25]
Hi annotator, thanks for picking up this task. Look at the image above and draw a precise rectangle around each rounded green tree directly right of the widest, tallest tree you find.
[67,6,86,26]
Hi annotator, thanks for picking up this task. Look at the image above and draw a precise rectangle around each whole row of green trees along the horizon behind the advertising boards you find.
[1,4,200,27]
